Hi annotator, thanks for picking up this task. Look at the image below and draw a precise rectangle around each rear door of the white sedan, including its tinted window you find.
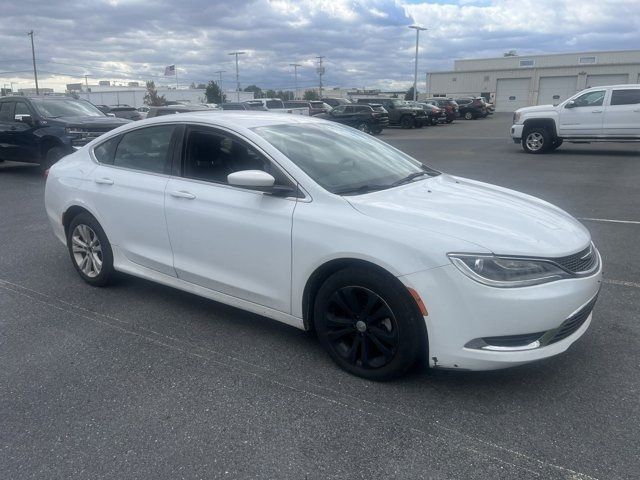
[82,124,182,277]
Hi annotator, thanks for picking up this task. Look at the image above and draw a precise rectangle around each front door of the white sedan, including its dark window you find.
[165,126,296,313]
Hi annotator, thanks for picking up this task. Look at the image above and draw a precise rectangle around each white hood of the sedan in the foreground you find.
[345,174,591,257]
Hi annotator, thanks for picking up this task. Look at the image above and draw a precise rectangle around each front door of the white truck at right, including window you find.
[559,88,607,137]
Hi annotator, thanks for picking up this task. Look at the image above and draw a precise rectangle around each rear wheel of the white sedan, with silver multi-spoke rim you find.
[67,212,115,287]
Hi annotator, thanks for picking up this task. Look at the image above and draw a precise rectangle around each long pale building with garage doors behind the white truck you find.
[427,50,640,112]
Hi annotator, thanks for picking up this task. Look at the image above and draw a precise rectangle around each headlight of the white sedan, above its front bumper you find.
[448,253,571,288]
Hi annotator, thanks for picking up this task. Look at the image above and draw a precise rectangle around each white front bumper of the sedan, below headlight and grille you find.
[400,265,602,370]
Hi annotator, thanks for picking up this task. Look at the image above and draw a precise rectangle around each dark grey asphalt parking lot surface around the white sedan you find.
[0,114,640,480]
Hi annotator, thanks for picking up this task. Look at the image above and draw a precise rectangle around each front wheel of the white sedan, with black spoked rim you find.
[314,267,427,380]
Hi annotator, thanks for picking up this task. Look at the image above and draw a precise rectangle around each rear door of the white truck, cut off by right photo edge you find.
[602,88,640,137]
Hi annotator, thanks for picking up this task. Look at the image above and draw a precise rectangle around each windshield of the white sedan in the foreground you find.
[253,123,439,195]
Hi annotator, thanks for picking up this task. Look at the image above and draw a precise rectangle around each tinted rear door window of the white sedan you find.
[113,125,176,173]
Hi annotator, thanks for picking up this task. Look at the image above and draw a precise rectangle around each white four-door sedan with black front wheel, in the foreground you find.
[45,112,602,379]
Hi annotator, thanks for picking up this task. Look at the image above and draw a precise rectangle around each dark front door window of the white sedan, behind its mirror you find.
[183,129,288,185]
